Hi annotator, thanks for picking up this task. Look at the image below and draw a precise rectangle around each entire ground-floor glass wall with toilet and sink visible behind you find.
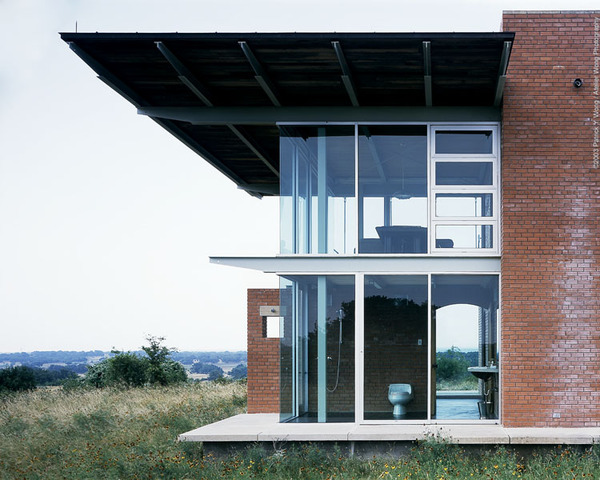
[280,274,500,422]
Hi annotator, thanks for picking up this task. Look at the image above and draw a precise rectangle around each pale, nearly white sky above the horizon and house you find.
[0,0,597,352]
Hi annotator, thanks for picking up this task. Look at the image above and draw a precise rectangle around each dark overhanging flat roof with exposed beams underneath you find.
[61,33,514,196]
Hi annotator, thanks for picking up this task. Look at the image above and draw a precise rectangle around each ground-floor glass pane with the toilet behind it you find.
[364,275,429,420]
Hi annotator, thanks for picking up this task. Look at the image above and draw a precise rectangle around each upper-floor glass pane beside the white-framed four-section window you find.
[358,126,427,253]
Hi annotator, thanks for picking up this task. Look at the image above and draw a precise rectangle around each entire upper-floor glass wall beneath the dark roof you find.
[280,125,499,255]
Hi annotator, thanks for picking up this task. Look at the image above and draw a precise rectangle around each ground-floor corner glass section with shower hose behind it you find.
[281,276,355,422]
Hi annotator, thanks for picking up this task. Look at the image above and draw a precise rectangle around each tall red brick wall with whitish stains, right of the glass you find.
[502,12,600,427]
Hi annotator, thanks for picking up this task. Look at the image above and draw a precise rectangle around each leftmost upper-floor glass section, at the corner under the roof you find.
[280,126,356,254]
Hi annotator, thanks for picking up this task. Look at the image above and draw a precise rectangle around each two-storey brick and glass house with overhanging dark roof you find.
[62,11,600,450]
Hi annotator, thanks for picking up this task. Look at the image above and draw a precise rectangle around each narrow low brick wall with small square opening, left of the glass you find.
[248,288,279,413]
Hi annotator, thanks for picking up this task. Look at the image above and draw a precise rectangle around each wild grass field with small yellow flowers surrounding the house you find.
[0,383,600,480]
